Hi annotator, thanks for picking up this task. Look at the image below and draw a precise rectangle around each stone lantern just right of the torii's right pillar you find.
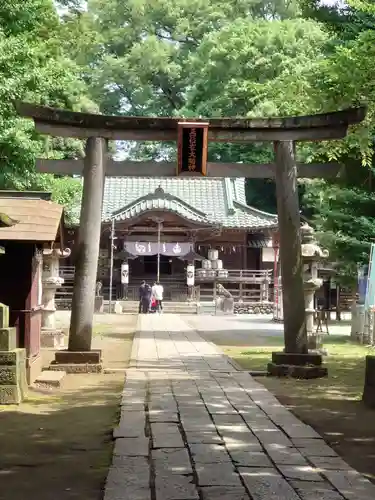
[301,224,329,349]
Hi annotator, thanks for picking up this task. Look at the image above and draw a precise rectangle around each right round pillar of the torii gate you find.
[274,141,308,354]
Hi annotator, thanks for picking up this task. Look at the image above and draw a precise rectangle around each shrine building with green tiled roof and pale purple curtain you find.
[60,177,277,302]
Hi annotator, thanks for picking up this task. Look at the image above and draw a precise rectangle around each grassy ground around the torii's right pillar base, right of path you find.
[222,335,375,483]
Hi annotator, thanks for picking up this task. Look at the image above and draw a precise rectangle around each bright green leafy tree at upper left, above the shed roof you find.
[0,0,95,220]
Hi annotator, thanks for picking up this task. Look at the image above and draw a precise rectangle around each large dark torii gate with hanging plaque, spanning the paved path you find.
[16,103,366,363]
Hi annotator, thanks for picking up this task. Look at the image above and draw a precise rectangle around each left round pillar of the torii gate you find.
[68,137,107,351]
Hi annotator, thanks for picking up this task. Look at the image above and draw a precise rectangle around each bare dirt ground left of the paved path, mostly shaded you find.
[0,316,136,500]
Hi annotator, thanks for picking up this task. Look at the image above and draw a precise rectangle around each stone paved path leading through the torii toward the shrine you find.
[104,315,375,500]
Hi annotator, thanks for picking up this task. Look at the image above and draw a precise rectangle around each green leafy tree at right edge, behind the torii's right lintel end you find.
[304,0,375,282]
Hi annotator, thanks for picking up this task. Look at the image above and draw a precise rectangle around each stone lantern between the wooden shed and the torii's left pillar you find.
[41,248,71,349]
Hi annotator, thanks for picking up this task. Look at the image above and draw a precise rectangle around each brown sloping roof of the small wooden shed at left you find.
[0,191,63,242]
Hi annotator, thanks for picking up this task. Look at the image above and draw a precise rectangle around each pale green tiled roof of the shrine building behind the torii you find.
[102,177,277,230]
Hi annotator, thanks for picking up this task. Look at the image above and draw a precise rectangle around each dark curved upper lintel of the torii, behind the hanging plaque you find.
[15,102,366,142]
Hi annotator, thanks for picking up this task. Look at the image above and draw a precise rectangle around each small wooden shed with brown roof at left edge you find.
[0,191,63,383]
